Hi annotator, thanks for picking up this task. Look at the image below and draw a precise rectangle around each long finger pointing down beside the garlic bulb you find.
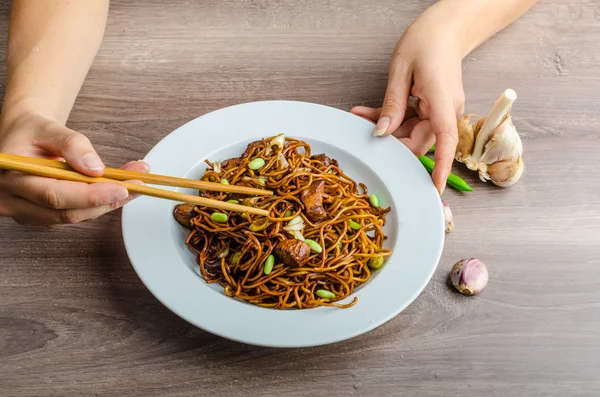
[431,95,458,194]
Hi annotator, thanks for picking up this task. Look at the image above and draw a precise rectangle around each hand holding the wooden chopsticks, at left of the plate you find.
[0,114,150,226]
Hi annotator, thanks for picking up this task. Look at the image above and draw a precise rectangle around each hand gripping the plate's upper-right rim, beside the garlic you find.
[351,7,465,193]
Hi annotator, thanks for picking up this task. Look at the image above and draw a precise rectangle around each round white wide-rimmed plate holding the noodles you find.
[123,101,444,347]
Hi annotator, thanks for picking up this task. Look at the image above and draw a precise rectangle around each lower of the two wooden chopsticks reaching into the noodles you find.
[0,153,269,216]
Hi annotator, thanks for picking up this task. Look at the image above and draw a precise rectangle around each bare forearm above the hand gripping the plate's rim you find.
[419,0,537,56]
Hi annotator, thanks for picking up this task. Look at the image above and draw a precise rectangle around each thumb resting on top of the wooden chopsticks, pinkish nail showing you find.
[37,125,106,176]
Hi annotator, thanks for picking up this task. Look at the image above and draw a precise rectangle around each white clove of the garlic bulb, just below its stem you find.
[479,116,523,164]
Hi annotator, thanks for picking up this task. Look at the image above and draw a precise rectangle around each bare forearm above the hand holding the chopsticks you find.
[2,0,109,124]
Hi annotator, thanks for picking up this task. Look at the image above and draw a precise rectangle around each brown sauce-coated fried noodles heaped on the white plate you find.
[180,136,391,309]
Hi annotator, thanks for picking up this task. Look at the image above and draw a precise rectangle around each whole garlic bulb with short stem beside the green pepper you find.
[455,89,524,187]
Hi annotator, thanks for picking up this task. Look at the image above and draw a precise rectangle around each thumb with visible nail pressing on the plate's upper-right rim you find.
[373,55,412,136]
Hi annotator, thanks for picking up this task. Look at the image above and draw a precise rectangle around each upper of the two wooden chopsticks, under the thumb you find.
[0,153,273,196]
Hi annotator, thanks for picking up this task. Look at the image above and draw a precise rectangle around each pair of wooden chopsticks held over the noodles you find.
[0,153,273,216]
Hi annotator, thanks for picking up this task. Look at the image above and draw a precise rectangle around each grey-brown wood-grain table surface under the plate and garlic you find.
[0,0,600,396]
